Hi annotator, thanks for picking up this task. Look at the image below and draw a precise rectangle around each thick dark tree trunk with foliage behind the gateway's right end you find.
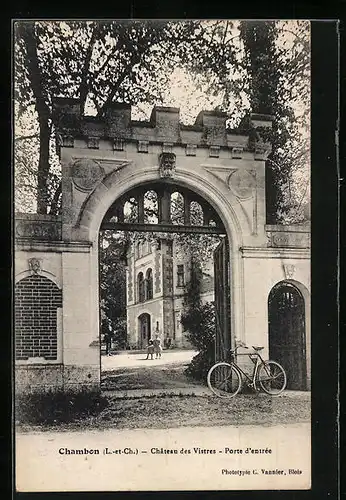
[240,21,310,223]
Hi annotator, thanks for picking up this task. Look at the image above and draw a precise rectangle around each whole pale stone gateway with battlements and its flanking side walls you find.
[15,98,310,393]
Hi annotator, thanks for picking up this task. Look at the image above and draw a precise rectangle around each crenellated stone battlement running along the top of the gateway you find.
[54,98,272,154]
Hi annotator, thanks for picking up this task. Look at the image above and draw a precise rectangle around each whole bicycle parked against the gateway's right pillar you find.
[207,344,287,398]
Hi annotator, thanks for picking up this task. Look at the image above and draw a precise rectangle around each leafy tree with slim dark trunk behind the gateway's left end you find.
[14,20,222,213]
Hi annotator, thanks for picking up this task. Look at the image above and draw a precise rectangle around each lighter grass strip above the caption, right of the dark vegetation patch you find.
[17,392,310,432]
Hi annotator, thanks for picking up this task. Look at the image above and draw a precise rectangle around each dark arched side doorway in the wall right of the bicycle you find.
[268,281,307,390]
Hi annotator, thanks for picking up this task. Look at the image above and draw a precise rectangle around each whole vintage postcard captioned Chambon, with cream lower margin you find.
[13,19,311,492]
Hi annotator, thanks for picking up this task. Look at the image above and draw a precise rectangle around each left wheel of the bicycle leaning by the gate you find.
[207,363,241,398]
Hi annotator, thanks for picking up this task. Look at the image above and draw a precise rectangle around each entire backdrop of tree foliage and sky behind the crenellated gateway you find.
[14,20,310,223]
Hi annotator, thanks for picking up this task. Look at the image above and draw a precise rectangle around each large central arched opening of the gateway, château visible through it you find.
[99,182,231,390]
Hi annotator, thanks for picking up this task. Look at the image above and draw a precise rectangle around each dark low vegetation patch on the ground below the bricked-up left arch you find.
[15,389,108,424]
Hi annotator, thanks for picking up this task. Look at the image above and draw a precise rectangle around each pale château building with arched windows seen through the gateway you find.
[126,238,214,349]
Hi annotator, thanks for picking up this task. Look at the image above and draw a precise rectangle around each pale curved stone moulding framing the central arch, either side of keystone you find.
[80,163,247,348]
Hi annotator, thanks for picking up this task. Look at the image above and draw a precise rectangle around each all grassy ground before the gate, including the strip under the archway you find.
[16,362,310,432]
